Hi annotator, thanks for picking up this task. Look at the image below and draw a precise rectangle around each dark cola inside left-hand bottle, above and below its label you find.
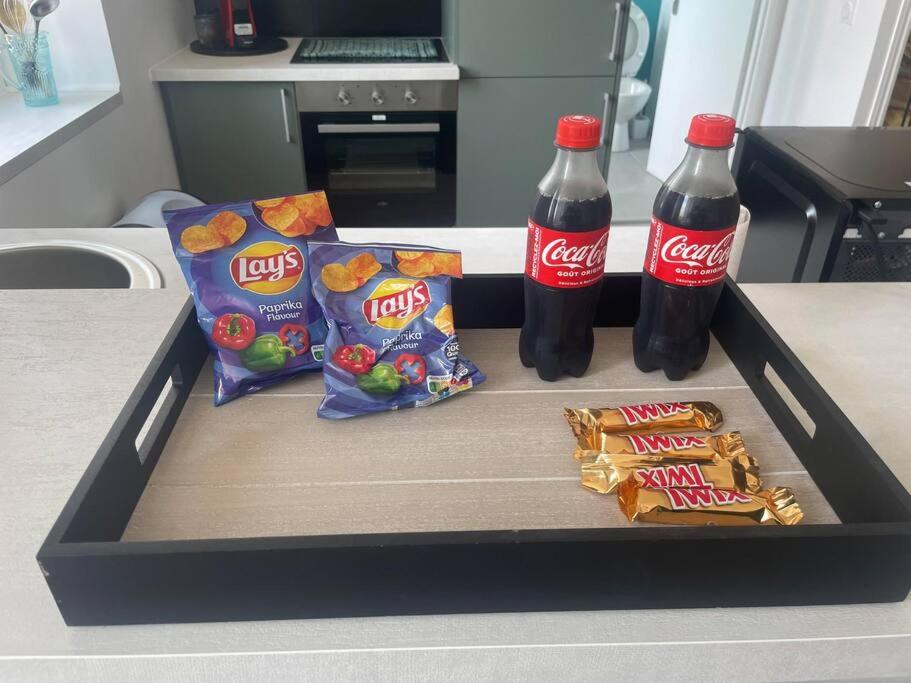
[519,193,613,382]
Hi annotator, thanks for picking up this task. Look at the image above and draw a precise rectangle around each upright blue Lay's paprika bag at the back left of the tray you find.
[165,192,337,405]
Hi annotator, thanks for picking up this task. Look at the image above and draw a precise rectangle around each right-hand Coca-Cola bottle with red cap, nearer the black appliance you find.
[633,114,740,380]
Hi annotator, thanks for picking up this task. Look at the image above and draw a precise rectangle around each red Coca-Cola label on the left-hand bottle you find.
[525,219,610,289]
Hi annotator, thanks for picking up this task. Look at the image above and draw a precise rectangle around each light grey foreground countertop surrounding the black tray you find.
[0,229,911,681]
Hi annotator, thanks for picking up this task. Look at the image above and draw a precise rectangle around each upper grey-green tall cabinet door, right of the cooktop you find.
[442,0,626,78]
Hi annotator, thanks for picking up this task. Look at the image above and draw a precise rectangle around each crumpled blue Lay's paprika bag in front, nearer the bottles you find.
[307,242,485,419]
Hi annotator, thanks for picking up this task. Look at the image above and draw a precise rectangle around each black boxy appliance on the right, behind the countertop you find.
[734,127,911,282]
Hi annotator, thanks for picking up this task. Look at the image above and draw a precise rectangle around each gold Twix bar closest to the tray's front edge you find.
[617,478,803,526]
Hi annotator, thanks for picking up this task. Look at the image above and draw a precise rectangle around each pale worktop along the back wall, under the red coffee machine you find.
[149,38,459,81]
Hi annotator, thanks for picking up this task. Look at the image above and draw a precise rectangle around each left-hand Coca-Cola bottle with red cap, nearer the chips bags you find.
[519,114,612,382]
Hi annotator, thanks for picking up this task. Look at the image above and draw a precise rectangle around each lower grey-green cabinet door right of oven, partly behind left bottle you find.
[456,78,613,226]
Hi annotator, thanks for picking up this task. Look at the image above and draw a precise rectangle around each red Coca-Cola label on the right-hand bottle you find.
[644,216,737,287]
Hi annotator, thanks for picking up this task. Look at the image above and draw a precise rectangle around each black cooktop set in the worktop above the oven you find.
[291,38,447,64]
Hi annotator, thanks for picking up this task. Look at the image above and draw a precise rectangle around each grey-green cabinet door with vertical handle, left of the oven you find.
[161,83,307,203]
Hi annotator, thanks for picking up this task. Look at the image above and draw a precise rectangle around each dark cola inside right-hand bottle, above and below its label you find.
[633,187,740,381]
